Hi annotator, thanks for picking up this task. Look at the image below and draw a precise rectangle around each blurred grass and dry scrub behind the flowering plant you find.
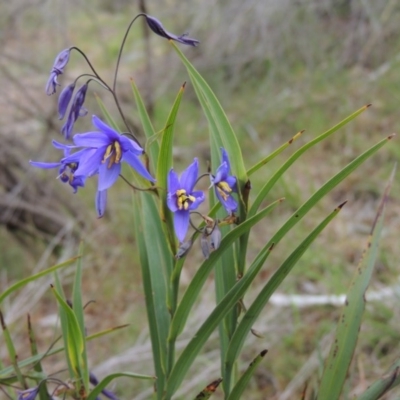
[0,0,400,400]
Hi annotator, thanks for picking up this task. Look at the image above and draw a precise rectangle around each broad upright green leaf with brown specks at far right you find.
[317,163,393,400]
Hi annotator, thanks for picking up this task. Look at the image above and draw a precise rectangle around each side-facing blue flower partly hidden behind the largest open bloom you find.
[29,140,86,193]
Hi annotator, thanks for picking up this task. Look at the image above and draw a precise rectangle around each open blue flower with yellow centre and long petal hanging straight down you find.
[167,158,204,243]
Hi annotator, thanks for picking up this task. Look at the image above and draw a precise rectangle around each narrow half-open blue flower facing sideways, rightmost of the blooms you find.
[210,147,237,214]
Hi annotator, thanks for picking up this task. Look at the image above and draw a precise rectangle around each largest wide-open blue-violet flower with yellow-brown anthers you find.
[61,115,155,192]
